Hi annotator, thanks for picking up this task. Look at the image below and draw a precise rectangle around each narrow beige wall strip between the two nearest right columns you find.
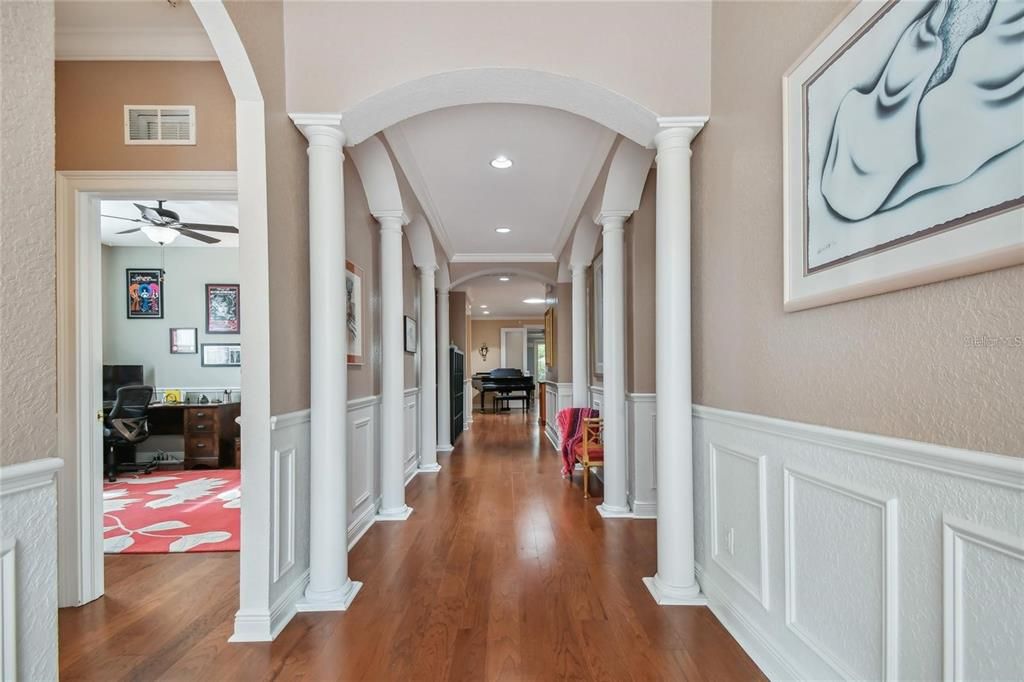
[626,171,657,393]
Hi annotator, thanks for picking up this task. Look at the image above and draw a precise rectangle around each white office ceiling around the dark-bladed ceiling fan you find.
[99,200,239,249]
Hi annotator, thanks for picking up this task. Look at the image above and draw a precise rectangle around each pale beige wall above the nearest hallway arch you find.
[286,1,711,116]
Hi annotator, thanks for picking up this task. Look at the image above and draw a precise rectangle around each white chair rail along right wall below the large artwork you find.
[693,404,1024,491]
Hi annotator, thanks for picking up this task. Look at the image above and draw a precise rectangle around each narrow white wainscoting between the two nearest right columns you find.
[626,393,657,518]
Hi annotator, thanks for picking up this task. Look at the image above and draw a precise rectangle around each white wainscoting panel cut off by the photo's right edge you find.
[942,517,1024,680]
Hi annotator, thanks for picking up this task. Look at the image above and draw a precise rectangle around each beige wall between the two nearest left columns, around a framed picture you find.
[345,159,381,399]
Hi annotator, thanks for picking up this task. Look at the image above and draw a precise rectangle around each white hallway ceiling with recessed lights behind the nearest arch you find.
[384,104,614,262]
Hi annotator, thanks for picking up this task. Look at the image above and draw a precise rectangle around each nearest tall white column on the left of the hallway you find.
[295,117,362,611]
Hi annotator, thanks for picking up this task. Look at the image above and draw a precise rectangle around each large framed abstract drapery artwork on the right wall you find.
[782,0,1024,310]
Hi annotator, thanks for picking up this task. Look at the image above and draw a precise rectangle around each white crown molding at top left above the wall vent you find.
[54,27,217,61]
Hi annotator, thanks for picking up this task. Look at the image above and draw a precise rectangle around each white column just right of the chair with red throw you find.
[597,213,630,517]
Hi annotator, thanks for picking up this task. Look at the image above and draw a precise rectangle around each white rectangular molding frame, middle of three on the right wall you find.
[782,465,899,680]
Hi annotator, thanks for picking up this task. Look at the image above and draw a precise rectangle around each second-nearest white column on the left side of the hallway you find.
[374,214,413,521]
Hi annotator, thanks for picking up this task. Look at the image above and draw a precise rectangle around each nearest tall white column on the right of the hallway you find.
[644,121,707,604]
